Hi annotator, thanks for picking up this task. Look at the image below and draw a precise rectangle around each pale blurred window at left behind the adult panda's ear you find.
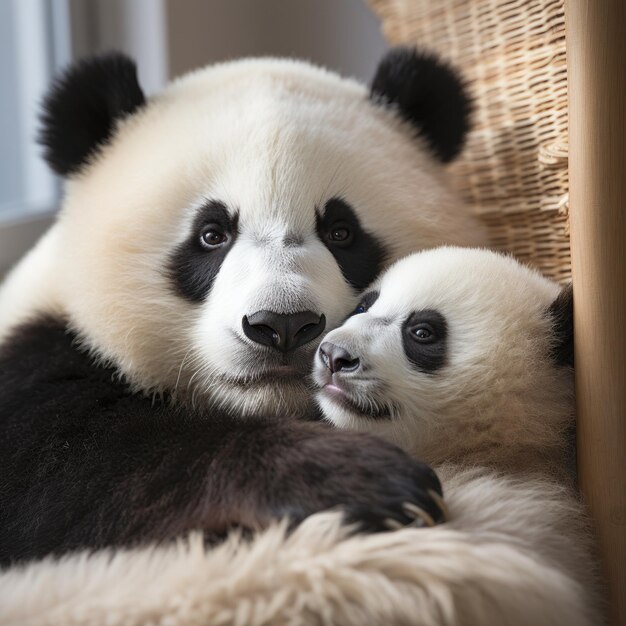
[0,0,70,271]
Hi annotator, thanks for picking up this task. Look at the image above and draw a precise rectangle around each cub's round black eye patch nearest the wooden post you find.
[402,309,448,374]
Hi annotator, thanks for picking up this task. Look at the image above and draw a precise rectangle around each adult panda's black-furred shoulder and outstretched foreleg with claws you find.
[0,319,442,565]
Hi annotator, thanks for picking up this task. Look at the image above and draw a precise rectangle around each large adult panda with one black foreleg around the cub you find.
[0,50,482,563]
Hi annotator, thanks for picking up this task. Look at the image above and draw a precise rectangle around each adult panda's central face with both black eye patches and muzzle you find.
[160,190,385,412]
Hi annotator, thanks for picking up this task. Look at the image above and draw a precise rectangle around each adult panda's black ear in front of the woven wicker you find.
[370,47,471,163]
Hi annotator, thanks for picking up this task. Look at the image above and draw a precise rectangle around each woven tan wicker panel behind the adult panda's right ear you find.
[368,0,570,281]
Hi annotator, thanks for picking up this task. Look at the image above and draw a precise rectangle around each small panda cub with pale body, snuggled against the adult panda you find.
[313,247,601,624]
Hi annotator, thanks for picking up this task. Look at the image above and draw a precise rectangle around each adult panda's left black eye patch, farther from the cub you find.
[168,200,238,302]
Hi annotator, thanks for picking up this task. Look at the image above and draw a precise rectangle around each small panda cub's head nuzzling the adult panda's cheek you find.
[313,248,573,461]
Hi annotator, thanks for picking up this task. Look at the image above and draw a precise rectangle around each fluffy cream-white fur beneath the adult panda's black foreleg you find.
[0,470,598,626]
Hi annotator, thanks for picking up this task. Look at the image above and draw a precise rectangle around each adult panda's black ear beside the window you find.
[39,52,145,176]
